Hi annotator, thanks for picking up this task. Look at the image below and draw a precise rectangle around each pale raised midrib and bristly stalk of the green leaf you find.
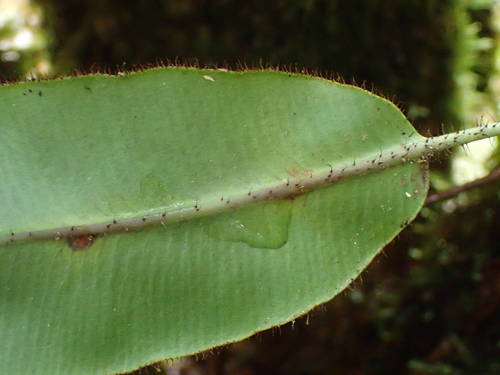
[0,123,500,244]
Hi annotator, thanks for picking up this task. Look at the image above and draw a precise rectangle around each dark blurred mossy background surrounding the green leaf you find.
[0,0,500,375]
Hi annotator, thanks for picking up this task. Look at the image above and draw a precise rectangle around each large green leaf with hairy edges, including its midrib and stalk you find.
[0,68,496,375]
